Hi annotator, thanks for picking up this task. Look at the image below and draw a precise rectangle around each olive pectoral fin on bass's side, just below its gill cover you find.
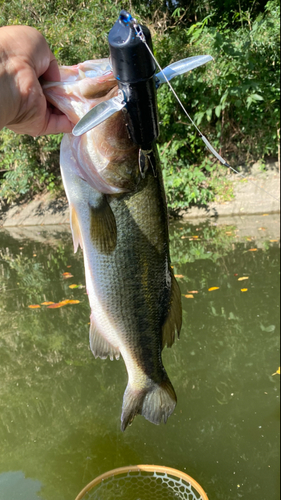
[89,196,117,254]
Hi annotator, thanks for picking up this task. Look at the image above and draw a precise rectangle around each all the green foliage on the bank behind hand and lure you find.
[0,0,280,209]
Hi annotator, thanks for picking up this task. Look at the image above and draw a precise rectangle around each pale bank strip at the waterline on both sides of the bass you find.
[0,162,280,228]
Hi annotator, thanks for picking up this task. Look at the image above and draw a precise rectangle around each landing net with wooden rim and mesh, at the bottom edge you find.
[76,465,208,500]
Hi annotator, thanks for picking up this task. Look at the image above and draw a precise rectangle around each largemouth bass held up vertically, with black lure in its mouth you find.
[43,59,181,430]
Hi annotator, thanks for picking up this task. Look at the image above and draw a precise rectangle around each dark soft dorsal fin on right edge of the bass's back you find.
[162,270,182,348]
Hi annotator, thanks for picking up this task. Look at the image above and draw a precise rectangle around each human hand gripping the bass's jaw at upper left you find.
[0,26,73,137]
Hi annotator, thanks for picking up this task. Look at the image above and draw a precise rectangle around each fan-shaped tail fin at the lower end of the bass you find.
[121,378,177,431]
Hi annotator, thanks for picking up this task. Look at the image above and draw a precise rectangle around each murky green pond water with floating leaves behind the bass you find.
[0,216,280,500]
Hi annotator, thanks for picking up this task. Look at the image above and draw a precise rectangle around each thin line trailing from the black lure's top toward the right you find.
[133,19,279,202]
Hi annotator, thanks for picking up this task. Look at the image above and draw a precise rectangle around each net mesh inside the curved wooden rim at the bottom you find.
[77,470,208,500]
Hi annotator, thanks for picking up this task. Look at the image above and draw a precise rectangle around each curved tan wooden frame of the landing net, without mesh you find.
[75,464,209,500]
